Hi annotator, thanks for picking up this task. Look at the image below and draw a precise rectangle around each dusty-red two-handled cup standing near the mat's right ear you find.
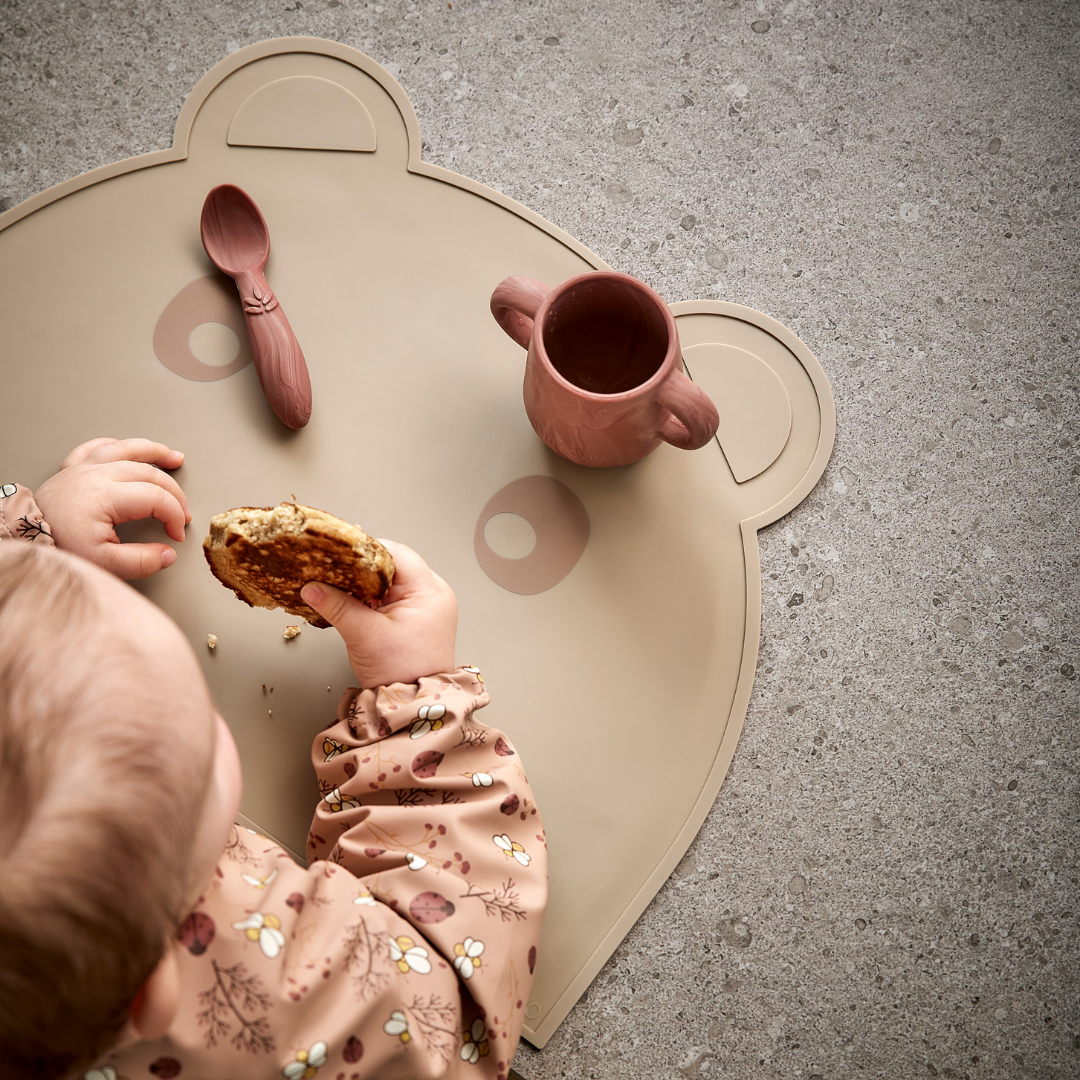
[491,270,719,468]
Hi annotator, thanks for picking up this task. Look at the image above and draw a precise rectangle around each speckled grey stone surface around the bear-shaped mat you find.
[0,0,1080,1080]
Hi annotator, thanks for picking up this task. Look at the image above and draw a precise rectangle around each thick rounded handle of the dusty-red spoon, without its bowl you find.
[235,271,311,428]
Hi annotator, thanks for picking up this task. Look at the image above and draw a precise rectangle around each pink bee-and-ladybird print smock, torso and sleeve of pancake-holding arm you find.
[86,667,546,1080]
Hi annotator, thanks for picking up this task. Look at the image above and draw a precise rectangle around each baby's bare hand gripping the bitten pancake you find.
[300,540,458,689]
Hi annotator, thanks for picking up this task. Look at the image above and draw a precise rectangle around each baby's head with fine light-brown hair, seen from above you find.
[0,541,240,1078]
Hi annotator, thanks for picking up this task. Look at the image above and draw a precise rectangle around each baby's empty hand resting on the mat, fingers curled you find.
[33,438,191,580]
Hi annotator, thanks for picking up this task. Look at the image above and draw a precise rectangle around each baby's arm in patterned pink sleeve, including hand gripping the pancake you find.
[305,541,548,1077]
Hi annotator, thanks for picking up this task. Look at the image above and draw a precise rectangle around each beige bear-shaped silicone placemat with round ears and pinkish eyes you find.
[0,38,835,1045]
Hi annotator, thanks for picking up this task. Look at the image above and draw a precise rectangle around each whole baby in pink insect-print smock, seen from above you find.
[0,440,546,1080]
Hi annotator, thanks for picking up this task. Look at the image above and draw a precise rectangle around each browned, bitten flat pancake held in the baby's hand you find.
[203,502,394,627]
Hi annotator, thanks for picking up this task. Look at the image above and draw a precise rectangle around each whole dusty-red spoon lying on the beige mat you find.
[200,184,311,428]
